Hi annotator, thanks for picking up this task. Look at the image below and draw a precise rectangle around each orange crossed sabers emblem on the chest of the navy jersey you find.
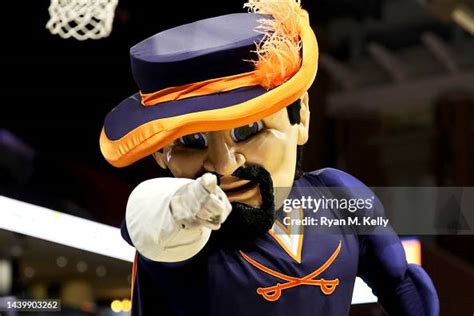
[240,241,342,302]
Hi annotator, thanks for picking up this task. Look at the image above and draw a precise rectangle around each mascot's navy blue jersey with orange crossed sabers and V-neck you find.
[122,169,434,316]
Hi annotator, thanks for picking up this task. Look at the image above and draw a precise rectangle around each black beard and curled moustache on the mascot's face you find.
[211,165,275,248]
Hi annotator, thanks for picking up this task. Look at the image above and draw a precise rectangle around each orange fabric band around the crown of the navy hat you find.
[140,71,260,106]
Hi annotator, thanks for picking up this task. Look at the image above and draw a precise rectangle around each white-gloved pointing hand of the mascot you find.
[170,173,232,230]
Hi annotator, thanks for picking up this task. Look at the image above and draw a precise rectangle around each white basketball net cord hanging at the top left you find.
[46,0,118,41]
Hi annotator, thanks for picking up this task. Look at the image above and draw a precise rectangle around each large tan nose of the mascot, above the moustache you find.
[204,133,245,176]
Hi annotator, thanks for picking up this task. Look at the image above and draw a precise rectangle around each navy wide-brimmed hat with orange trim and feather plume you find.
[100,0,318,167]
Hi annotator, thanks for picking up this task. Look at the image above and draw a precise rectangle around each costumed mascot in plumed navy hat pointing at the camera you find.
[100,0,439,316]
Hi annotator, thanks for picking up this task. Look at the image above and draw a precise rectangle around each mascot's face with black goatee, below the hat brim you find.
[154,94,309,242]
